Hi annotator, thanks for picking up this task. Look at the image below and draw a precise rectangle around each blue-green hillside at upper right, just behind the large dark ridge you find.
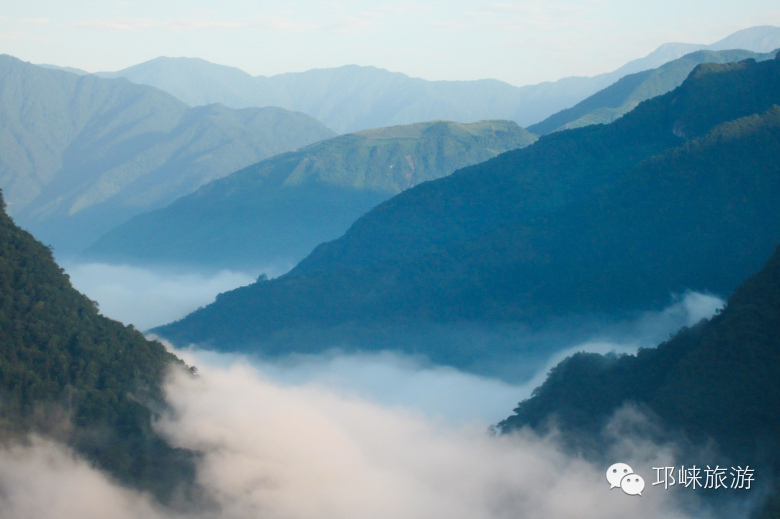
[528,50,777,135]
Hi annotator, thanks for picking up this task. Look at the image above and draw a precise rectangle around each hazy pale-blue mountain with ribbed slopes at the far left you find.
[0,56,334,252]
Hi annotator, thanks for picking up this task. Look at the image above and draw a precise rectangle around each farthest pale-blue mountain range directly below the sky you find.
[99,26,780,133]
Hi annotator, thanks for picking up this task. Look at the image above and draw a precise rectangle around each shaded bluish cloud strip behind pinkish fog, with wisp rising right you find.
[189,292,724,427]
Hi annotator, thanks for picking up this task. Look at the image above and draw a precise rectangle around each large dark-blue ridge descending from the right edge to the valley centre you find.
[157,53,780,378]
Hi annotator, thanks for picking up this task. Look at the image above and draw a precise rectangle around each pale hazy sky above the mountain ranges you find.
[0,0,780,85]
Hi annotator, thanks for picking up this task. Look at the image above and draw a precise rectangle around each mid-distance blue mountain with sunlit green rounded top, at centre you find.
[85,121,535,271]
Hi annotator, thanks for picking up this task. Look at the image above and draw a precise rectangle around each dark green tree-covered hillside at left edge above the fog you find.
[0,190,194,499]
